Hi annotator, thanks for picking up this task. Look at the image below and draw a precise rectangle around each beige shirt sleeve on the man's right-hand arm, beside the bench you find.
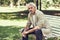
[36,12,45,29]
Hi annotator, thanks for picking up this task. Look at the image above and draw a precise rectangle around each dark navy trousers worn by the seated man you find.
[22,28,43,40]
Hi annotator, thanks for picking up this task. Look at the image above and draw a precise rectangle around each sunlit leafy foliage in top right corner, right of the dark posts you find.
[41,0,60,9]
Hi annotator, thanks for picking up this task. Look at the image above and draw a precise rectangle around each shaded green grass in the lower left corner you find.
[0,26,21,40]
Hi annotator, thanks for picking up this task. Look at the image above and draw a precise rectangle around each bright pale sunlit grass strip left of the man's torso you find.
[0,20,27,27]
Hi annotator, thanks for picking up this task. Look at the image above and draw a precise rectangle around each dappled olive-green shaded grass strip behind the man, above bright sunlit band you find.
[0,13,27,19]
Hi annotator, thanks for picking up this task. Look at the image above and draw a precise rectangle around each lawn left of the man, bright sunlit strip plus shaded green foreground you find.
[0,19,26,40]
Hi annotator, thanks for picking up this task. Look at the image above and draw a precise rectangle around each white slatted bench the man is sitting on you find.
[45,15,60,40]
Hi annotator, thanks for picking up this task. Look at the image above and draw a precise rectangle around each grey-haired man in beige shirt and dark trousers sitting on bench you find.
[22,3,48,40]
